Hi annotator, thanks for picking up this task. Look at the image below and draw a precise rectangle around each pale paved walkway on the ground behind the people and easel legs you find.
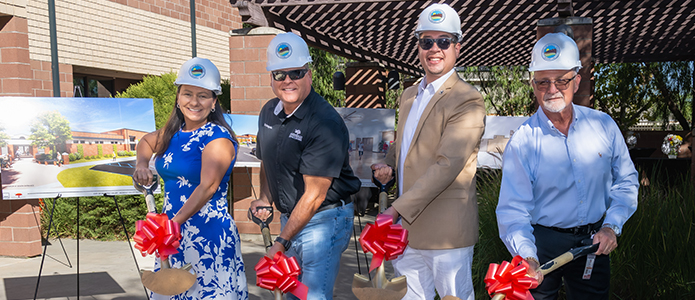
[0,216,393,300]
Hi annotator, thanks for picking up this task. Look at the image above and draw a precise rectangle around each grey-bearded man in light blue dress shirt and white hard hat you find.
[497,33,638,300]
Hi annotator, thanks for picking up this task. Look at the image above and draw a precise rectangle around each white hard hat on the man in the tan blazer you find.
[415,3,463,42]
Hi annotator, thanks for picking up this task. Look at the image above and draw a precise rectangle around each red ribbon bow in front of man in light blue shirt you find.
[485,255,538,300]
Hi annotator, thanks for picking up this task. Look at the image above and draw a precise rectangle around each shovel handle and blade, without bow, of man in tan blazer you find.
[352,176,408,300]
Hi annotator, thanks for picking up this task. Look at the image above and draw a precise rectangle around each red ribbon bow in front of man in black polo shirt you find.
[253,252,309,300]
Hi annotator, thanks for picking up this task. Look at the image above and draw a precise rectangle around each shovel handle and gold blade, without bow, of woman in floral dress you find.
[133,175,196,296]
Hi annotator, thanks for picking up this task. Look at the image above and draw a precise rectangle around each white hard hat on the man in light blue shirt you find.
[528,33,582,72]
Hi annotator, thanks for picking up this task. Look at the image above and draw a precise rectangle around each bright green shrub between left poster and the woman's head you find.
[115,72,176,129]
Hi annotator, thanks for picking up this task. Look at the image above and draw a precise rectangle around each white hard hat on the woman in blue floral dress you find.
[174,57,222,95]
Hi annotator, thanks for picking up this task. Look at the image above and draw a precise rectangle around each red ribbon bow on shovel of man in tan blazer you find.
[360,214,408,272]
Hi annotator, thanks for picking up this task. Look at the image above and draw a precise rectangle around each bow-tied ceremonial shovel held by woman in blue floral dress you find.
[133,175,196,296]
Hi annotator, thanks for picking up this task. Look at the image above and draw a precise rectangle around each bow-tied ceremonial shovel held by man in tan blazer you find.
[352,174,408,300]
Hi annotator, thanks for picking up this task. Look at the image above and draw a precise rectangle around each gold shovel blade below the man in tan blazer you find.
[352,274,408,300]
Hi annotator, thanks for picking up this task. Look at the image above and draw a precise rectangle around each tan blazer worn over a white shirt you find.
[386,73,485,249]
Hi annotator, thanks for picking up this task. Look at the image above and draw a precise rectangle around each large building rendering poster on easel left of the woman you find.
[0,97,155,199]
